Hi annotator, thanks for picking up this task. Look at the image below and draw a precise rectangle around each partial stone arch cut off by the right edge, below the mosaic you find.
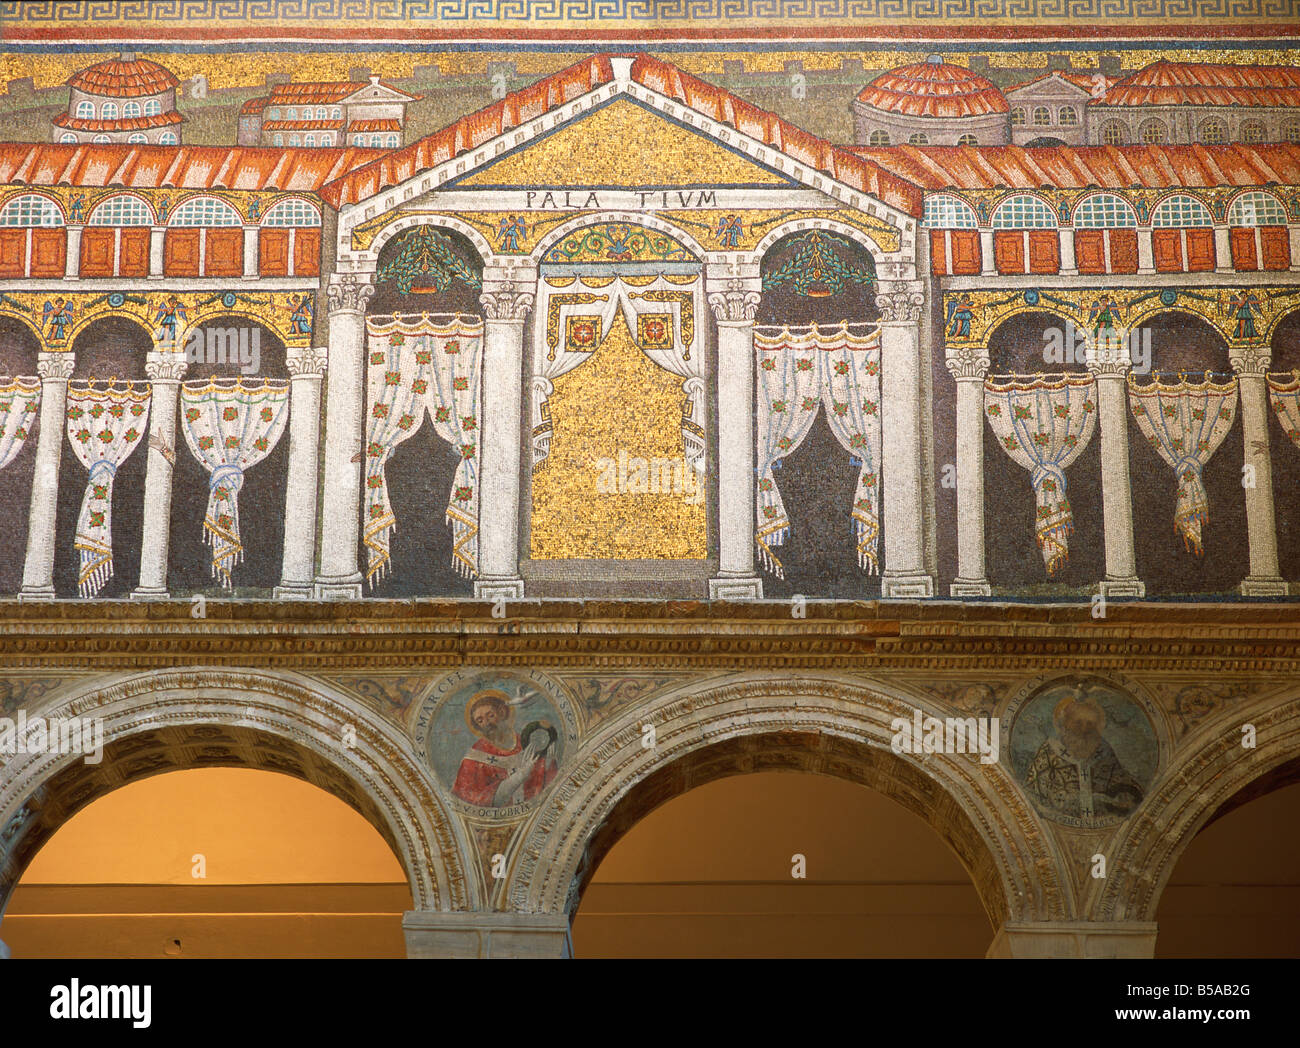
[1088,692,1300,922]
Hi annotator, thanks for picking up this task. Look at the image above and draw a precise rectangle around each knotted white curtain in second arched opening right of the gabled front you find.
[1128,373,1236,557]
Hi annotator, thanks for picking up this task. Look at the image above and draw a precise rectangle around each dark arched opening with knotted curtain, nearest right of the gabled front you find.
[977,311,1105,597]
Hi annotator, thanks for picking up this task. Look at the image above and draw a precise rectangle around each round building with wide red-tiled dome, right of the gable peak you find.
[850,55,1011,146]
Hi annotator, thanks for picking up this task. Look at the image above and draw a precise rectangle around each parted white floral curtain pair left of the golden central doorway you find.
[363,316,482,585]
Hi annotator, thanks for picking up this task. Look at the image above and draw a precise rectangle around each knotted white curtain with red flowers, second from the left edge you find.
[68,382,152,598]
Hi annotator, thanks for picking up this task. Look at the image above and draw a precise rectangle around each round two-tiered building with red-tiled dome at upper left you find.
[55,53,185,146]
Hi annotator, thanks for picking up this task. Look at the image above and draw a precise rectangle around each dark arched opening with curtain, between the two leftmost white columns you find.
[55,316,153,599]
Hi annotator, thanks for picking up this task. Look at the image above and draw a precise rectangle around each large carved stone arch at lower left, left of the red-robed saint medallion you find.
[0,668,476,913]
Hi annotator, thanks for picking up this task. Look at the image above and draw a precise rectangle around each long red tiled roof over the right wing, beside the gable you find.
[852,144,1300,190]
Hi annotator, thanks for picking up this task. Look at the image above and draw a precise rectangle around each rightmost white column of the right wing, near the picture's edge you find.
[1229,346,1287,597]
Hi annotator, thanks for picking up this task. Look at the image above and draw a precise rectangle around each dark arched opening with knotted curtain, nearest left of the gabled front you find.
[168,316,290,597]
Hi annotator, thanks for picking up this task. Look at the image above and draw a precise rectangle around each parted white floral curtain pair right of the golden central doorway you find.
[754,324,880,579]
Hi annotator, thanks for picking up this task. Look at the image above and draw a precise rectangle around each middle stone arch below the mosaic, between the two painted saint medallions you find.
[506,679,1074,927]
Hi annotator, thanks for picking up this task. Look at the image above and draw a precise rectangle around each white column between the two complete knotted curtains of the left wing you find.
[131,351,186,601]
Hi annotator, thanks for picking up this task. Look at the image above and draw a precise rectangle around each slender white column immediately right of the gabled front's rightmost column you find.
[945,347,992,597]
